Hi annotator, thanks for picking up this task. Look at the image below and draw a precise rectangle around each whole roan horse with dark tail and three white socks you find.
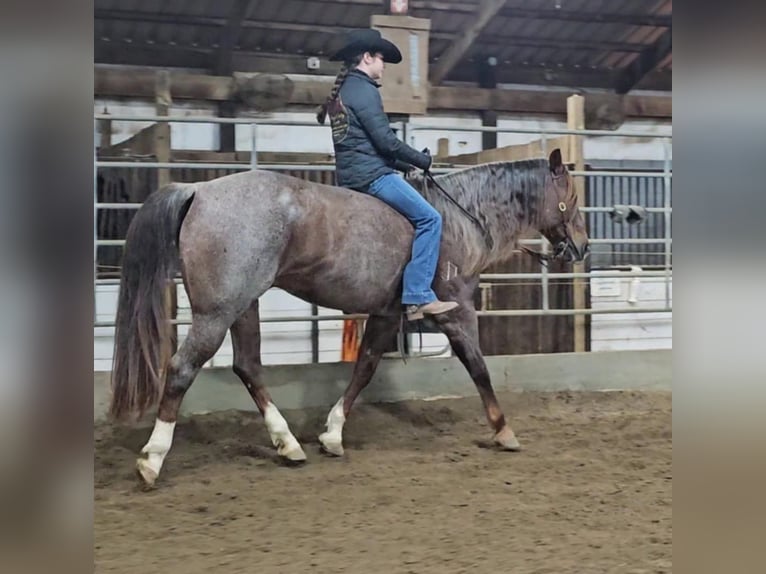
[110,150,588,485]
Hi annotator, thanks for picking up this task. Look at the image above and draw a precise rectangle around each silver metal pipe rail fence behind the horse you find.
[94,114,672,340]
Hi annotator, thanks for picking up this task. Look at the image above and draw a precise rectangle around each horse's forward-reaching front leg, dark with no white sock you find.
[433,299,521,451]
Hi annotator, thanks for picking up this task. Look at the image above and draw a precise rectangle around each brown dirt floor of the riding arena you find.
[94,392,672,574]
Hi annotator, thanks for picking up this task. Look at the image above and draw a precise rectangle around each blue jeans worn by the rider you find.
[367,173,442,305]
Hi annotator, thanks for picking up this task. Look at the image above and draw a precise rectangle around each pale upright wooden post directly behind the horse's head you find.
[567,95,587,352]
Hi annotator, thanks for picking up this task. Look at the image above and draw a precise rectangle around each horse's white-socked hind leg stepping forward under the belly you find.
[231,299,306,462]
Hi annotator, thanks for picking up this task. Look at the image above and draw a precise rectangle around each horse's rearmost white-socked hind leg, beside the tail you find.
[136,314,231,486]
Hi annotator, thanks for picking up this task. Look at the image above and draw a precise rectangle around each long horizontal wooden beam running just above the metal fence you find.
[94,67,673,119]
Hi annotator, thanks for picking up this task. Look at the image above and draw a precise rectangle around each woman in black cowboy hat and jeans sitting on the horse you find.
[317,29,458,320]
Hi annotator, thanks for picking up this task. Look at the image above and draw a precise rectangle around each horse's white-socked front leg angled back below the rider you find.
[319,316,399,456]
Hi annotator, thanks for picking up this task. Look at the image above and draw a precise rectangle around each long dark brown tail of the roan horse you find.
[109,183,194,420]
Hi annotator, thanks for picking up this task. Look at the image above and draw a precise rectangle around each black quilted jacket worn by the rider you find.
[328,70,431,191]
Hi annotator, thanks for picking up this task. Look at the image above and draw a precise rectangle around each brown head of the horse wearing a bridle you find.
[538,149,590,262]
